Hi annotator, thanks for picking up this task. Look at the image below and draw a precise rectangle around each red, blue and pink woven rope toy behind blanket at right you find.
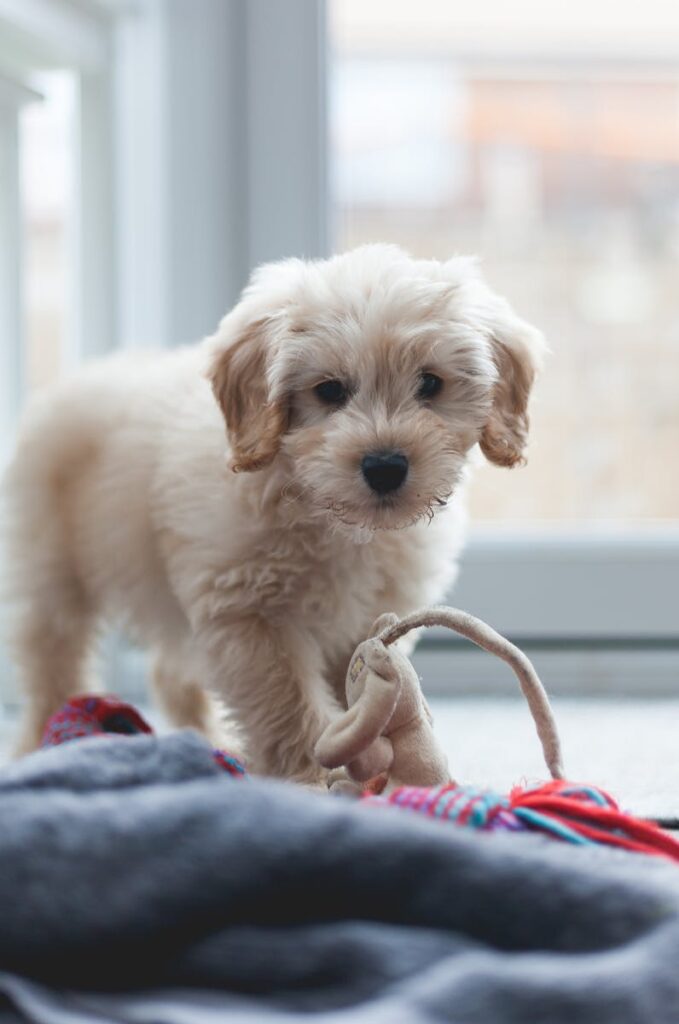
[364,779,679,861]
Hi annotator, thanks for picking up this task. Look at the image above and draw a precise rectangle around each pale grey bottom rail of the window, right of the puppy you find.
[416,523,679,696]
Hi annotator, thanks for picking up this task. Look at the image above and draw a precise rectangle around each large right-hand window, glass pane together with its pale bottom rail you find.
[330,0,679,688]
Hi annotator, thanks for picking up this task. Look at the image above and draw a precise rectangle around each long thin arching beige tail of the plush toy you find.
[378,607,563,778]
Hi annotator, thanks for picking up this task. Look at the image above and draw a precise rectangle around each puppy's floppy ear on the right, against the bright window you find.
[479,298,545,466]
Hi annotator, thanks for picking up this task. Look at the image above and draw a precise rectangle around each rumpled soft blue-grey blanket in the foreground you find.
[0,733,679,1024]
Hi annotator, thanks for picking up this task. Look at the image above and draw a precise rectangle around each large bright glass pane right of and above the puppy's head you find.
[332,0,679,522]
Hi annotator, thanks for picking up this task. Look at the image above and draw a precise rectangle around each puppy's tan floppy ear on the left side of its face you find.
[208,317,289,473]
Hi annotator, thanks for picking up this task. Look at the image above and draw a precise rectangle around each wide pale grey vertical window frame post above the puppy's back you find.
[116,0,328,344]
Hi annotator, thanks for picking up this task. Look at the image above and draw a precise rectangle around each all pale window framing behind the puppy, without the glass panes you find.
[0,0,679,692]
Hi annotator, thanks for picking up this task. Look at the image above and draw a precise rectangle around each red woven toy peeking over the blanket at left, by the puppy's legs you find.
[40,694,247,777]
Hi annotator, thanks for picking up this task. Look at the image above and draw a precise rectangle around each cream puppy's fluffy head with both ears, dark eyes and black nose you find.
[209,245,542,529]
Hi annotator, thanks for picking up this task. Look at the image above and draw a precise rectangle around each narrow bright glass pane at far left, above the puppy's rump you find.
[19,72,75,389]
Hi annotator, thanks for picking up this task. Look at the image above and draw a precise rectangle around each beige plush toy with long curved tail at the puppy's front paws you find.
[315,607,563,793]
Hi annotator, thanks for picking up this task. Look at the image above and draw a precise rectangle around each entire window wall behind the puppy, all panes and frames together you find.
[0,0,679,691]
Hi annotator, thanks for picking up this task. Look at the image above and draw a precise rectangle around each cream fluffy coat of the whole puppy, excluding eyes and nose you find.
[4,245,542,782]
